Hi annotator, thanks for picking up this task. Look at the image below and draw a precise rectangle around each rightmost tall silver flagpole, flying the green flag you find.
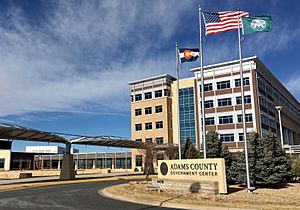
[238,11,251,192]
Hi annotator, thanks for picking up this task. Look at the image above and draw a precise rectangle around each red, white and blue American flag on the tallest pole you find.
[202,11,249,36]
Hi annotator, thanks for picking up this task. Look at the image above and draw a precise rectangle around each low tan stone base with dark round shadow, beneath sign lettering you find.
[153,179,219,194]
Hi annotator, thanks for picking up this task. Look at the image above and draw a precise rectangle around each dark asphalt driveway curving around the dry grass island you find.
[0,180,178,210]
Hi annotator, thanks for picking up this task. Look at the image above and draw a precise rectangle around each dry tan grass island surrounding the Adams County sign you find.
[107,182,300,210]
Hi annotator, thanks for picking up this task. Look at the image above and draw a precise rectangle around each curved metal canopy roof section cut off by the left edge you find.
[0,123,68,143]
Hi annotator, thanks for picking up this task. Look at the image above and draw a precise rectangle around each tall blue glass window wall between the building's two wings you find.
[179,87,196,144]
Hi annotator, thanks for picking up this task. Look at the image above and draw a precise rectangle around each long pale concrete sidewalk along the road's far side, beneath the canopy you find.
[0,172,143,191]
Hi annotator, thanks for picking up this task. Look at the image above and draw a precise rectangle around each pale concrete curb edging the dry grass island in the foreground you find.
[98,187,256,210]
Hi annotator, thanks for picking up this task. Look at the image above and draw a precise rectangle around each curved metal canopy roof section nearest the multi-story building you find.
[70,136,148,149]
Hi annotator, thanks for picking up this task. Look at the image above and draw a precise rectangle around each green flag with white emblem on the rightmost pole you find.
[242,15,272,35]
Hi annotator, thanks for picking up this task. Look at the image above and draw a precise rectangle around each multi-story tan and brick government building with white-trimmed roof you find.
[129,57,300,170]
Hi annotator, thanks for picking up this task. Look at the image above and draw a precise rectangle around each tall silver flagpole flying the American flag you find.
[199,5,206,159]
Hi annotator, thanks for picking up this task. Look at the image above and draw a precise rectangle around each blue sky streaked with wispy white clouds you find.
[0,0,300,152]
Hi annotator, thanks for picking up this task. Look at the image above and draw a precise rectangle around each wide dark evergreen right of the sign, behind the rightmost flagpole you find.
[231,134,292,186]
